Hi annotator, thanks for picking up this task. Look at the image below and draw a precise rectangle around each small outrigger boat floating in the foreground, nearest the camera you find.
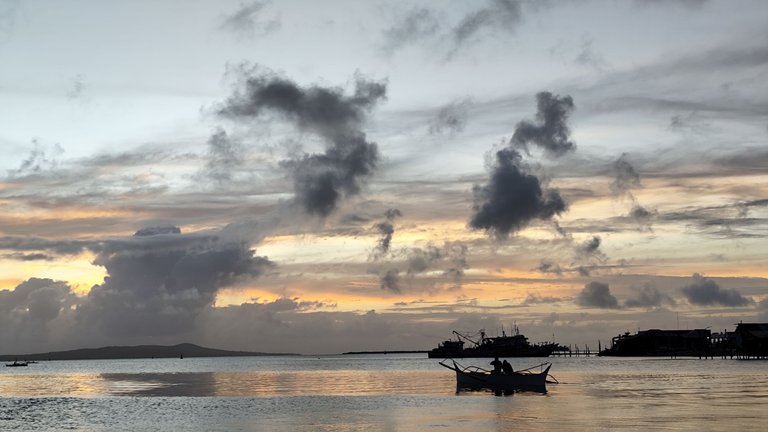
[440,360,557,393]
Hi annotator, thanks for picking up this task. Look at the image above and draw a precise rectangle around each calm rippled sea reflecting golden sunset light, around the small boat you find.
[0,354,768,432]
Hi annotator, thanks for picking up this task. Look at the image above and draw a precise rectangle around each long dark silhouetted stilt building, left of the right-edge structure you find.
[598,329,712,357]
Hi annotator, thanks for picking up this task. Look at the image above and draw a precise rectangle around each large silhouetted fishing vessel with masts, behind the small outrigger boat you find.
[427,326,566,358]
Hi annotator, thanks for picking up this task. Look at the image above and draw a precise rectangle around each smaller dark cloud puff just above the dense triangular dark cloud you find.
[510,92,576,156]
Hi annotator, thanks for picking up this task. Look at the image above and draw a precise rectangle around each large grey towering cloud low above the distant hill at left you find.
[78,227,273,337]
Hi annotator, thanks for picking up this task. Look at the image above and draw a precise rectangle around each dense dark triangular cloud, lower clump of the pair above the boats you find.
[469,148,567,239]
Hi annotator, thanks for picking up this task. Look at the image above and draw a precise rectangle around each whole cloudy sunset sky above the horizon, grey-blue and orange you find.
[0,0,768,354]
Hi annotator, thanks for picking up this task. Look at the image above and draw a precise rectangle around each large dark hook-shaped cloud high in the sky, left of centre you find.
[219,69,387,216]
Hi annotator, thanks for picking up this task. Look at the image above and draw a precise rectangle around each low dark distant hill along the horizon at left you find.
[0,343,297,361]
